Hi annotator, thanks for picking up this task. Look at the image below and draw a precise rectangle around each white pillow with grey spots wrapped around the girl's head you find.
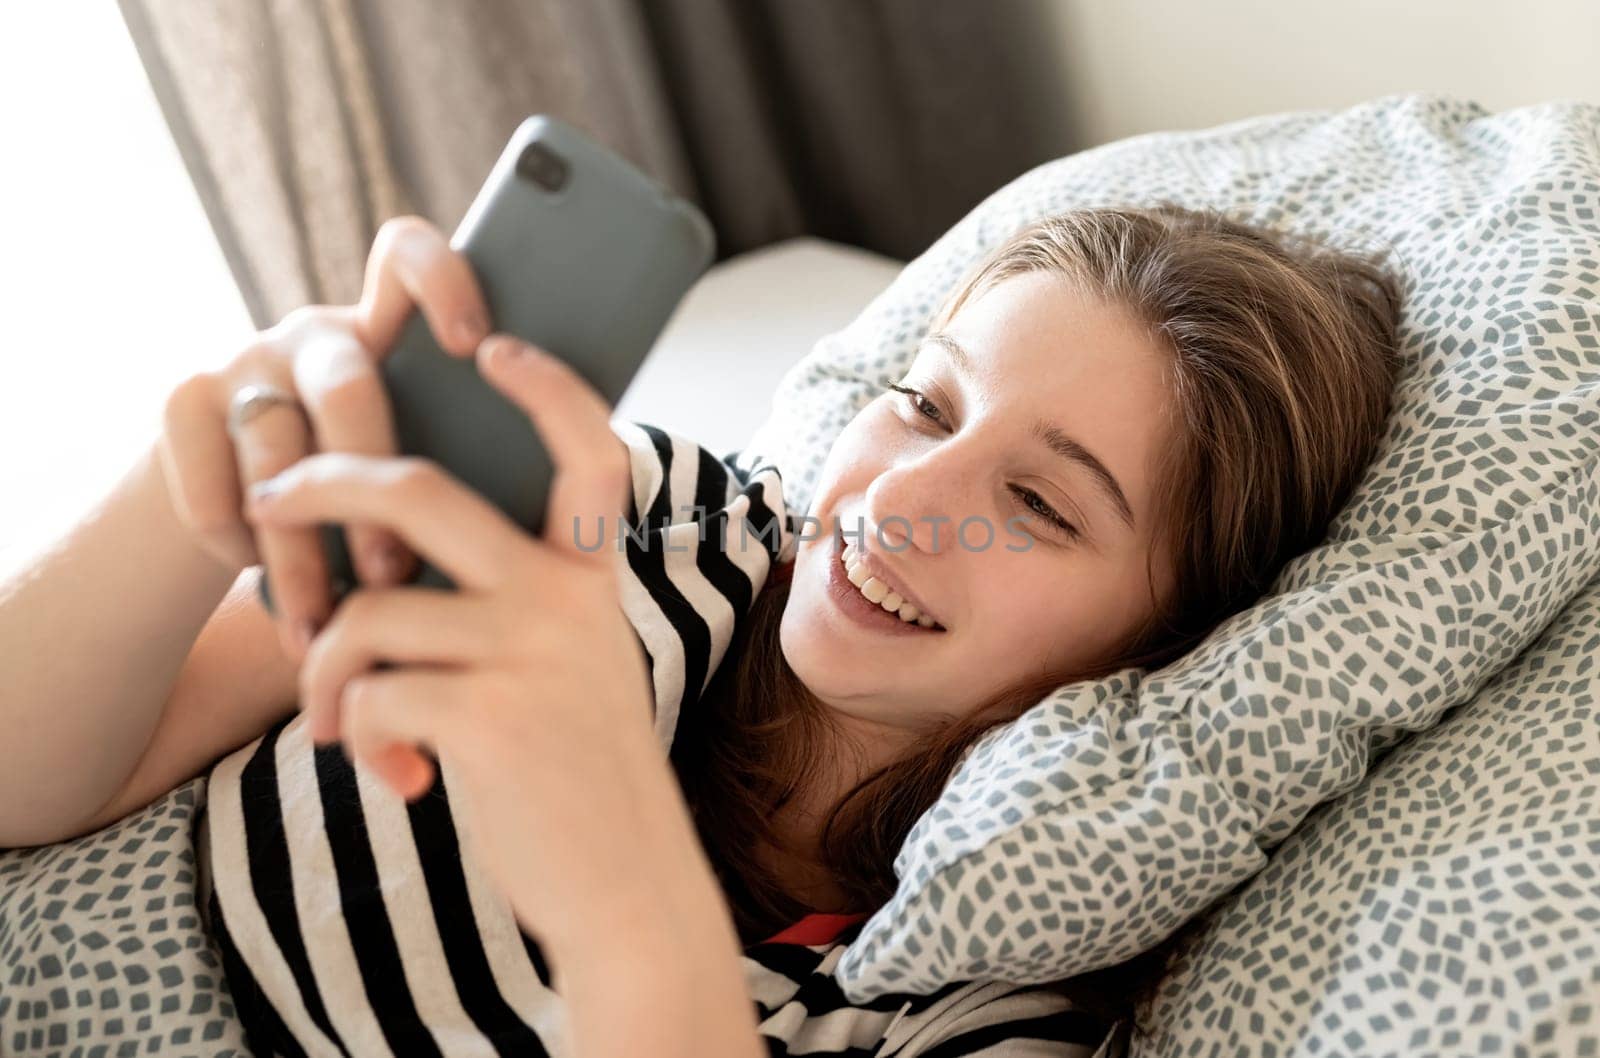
[739,93,1600,1002]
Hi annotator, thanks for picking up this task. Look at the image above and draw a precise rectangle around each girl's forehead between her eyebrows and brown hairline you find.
[917,272,1171,514]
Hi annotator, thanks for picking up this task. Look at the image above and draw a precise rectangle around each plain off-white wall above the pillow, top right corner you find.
[1021,0,1600,147]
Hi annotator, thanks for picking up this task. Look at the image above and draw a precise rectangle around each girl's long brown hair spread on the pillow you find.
[672,202,1400,984]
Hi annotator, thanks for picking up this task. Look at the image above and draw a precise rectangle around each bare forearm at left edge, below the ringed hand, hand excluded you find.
[0,447,237,847]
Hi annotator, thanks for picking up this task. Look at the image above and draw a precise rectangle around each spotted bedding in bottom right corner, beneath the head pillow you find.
[1131,557,1600,1058]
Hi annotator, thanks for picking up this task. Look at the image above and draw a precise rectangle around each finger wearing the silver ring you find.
[216,368,333,661]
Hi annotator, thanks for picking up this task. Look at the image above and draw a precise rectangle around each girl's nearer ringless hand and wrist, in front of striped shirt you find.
[246,335,665,920]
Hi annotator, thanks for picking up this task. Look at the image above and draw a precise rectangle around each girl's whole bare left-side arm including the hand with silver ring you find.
[0,216,488,847]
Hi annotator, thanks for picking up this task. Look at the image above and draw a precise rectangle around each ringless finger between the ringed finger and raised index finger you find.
[294,318,413,586]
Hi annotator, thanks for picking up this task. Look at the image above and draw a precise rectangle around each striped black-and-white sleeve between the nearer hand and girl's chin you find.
[611,421,795,747]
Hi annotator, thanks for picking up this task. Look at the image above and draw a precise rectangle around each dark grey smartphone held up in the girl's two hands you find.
[258,114,715,613]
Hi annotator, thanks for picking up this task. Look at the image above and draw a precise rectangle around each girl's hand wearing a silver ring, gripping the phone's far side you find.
[158,216,491,661]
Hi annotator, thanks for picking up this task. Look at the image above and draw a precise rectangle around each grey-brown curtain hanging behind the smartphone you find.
[118,0,1074,327]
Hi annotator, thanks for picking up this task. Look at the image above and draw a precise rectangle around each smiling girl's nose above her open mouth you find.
[864,440,986,554]
